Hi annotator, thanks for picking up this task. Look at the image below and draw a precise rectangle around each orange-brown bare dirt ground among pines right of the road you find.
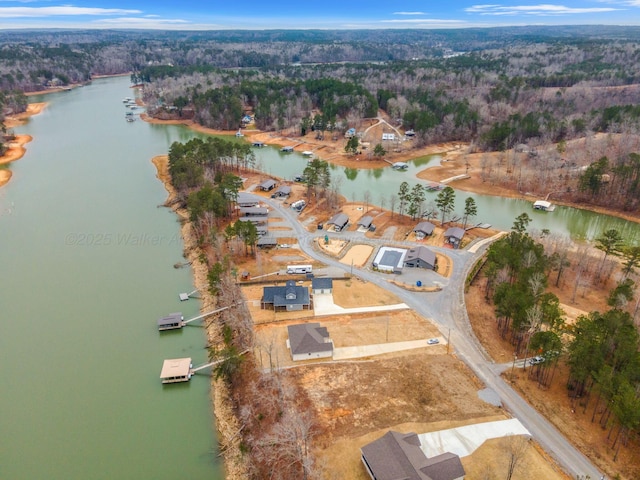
[465,272,640,480]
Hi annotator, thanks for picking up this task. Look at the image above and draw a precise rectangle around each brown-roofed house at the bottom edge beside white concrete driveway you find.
[360,431,465,480]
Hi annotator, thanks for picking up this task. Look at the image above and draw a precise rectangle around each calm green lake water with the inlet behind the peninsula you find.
[0,77,640,480]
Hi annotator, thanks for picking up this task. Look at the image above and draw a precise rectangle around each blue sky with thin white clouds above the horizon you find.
[0,0,640,30]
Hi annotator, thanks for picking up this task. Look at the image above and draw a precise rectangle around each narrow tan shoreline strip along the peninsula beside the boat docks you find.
[151,155,249,480]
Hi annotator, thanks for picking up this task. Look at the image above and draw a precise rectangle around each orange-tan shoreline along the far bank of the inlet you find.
[140,114,640,223]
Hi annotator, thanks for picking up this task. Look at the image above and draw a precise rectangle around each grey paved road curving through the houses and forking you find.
[256,192,601,479]
